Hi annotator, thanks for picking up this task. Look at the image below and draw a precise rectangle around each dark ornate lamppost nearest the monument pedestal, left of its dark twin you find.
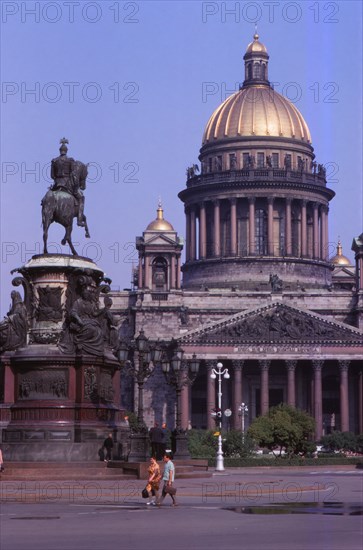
[118,330,162,462]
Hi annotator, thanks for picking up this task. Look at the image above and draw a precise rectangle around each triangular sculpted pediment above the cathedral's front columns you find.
[179,302,363,346]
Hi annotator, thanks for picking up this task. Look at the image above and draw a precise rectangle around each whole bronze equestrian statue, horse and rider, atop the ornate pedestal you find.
[41,138,90,256]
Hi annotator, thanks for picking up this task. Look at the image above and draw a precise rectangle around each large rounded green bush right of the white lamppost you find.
[248,405,315,457]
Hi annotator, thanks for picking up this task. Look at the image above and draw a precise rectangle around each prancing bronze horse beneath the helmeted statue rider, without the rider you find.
[41,160,90,256]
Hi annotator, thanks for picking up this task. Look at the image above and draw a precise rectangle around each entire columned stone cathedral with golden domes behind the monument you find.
[112,34,363,440]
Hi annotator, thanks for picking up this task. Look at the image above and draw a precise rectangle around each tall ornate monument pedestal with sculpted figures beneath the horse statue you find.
[1,254,128,462]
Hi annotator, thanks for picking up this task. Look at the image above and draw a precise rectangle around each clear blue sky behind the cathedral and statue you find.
[0,0,363,316]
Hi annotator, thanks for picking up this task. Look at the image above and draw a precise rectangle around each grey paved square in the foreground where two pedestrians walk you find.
[0,466,363,550]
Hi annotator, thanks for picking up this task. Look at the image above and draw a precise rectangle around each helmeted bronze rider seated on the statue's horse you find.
[50,138,85,227]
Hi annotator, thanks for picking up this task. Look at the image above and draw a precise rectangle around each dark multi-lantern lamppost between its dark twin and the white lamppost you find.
[162,347,199,460]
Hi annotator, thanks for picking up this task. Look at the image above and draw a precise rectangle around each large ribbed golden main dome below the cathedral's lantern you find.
[203,84,311,145]
